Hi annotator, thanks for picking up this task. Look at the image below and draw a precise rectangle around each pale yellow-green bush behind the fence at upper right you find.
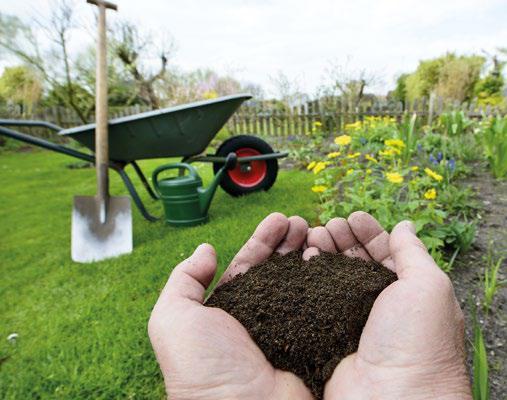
[405,53,485,102]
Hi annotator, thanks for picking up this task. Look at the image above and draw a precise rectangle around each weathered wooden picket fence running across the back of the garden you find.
[0,97,505,137]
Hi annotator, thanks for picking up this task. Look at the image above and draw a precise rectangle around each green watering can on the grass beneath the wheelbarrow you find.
[152,153,237,226]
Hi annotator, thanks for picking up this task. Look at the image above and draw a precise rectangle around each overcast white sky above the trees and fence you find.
[0,0,507,93]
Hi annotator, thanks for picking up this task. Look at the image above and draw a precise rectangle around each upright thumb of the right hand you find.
[389,221,440,279]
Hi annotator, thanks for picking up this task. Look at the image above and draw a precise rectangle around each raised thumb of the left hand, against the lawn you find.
[157,244,217,306]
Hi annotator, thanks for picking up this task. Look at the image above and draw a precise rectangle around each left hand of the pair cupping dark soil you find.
[148,213,313,400]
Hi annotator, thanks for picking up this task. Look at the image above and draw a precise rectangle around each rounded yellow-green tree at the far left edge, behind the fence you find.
[0,65,42,110]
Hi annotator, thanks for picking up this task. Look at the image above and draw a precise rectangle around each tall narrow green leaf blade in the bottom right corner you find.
[472,307,489,400]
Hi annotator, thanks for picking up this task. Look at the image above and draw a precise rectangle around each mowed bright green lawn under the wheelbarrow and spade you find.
[0,151,316,399]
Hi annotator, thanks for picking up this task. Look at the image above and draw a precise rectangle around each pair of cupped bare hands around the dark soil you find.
[148,212,471,400]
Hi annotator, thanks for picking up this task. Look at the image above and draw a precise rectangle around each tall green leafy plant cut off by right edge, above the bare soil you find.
[479,116,507,179]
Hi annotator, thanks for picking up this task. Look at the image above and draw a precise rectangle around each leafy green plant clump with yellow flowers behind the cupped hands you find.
[309,116,476,271]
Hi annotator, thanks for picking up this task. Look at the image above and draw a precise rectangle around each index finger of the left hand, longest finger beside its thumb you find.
[218,213,289,285]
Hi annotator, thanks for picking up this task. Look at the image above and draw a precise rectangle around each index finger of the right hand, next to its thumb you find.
[347,211,394,271]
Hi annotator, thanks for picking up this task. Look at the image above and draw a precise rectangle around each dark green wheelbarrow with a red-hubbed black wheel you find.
[0,94,288,225]
